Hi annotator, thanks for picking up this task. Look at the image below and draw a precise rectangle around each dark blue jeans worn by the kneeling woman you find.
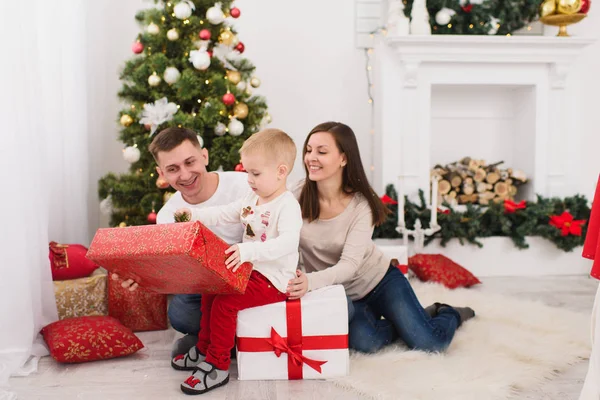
[349,266,460,353]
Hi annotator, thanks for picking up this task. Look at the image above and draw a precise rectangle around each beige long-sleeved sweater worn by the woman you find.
[294,188,390,300]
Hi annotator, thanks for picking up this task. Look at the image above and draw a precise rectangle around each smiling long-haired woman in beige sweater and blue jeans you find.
[288,122,475,353]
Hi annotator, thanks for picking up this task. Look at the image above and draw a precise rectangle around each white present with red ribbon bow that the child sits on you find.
[237,285,349,380]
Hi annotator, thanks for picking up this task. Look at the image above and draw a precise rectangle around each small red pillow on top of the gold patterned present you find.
[48,242,98,281]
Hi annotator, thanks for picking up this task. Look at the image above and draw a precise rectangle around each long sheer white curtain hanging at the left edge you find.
[0,0,89,399]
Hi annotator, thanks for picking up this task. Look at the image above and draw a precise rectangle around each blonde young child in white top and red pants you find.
[171,129,302,394]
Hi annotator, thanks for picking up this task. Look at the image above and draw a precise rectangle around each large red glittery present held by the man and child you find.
[87,221,252,294]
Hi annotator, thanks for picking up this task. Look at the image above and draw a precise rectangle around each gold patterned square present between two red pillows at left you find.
[54,274,108,319]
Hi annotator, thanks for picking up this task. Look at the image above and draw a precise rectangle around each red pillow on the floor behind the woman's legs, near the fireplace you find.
[408,254,481,289]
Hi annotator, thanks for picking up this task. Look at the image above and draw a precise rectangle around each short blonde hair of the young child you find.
[240,128,296,173]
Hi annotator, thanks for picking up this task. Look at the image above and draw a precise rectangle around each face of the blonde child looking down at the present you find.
[241,151,287,200]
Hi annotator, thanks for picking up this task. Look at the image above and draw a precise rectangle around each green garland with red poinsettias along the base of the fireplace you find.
[373,185,590,252]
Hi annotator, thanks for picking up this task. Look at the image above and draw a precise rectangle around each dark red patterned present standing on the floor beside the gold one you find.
[108,279,169,332]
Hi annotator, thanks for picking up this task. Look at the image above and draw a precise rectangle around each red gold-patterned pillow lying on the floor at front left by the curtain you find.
[42,316,144,363]
